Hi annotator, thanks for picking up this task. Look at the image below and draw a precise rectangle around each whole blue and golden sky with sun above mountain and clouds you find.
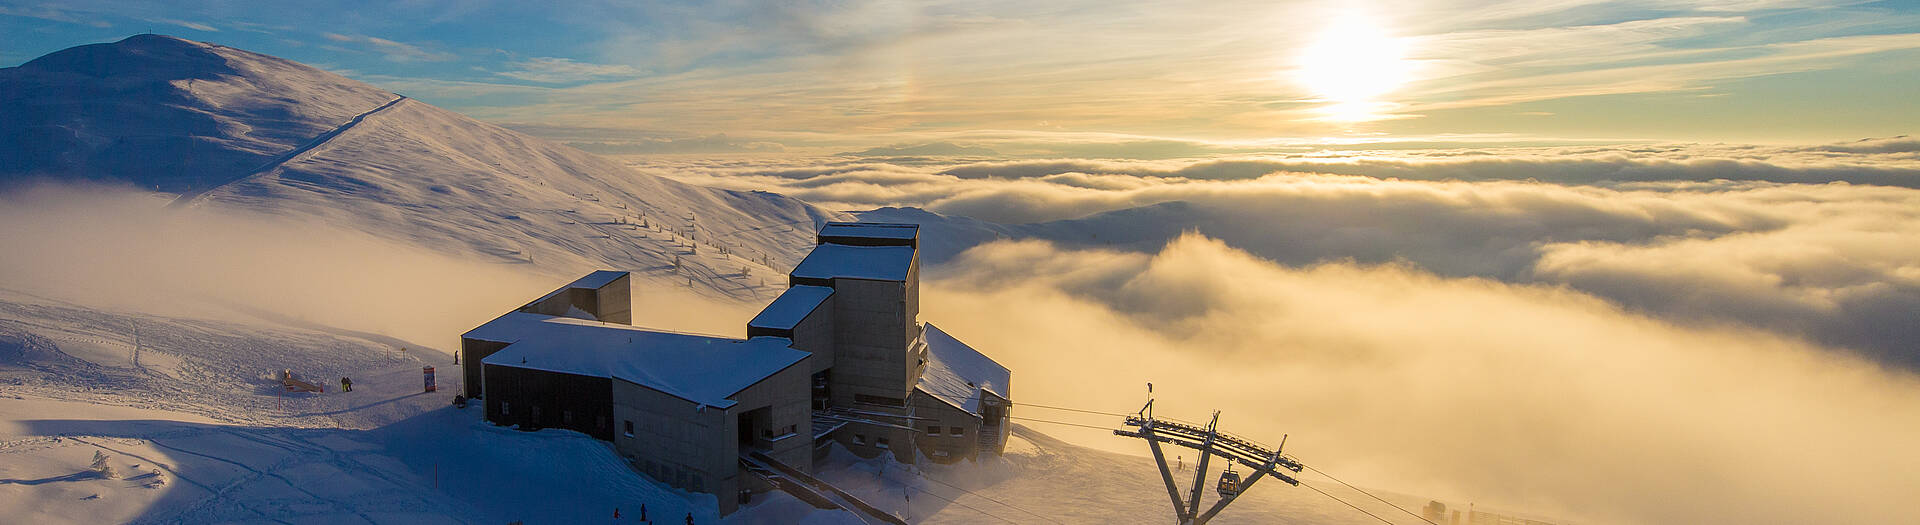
[0,0,1920,150]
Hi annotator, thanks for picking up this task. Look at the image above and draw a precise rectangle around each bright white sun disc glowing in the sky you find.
[1294,17,1413,121]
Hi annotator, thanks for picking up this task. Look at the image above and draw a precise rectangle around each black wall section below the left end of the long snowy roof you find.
[486,365,612,440]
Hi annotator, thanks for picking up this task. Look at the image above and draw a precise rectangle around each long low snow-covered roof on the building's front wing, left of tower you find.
[483,312,812,408]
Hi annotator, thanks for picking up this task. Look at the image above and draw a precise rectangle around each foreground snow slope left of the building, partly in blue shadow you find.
[0,292,748,523]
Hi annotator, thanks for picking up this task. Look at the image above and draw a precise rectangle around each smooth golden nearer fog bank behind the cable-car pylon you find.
[924,235,1920,523]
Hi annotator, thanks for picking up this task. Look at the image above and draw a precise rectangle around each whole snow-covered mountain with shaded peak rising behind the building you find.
[0,35,845,300]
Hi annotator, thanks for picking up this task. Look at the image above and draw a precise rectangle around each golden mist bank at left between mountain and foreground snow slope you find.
[0,187,557,352]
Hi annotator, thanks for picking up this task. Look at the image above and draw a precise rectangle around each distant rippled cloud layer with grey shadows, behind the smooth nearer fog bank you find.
[636,138,1920,369]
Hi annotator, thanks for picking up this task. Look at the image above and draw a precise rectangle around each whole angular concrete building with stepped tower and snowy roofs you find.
[461,223,1012,513]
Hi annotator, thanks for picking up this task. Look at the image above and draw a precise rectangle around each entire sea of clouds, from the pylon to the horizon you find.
[632,138,1920,523]
